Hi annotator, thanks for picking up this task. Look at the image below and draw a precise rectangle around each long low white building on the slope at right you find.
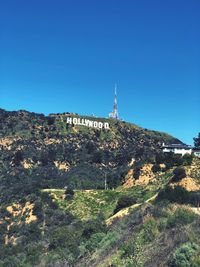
[162,143,192,156]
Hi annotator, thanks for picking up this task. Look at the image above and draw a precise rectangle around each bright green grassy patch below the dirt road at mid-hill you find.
[44,171,171,223]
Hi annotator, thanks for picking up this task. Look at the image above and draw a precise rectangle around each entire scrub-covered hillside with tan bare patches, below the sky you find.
[0,110,200,267]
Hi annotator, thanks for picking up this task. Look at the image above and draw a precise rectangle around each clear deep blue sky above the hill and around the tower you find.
[0,0,200,144]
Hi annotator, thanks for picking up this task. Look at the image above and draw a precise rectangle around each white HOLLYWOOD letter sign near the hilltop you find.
[67,117,110,129]
